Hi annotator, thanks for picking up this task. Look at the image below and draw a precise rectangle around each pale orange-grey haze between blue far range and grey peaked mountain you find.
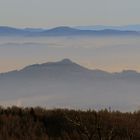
[0,37,140,73]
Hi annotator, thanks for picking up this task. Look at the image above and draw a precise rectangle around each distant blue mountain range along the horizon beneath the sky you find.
[0,26,140,36]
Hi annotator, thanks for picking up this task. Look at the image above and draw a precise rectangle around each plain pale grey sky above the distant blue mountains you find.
[0,0,140,27]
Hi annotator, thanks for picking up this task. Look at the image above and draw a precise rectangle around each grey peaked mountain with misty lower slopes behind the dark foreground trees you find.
[0,59,140,111]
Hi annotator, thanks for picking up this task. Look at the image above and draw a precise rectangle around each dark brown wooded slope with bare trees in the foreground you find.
[0,107,140,140]
